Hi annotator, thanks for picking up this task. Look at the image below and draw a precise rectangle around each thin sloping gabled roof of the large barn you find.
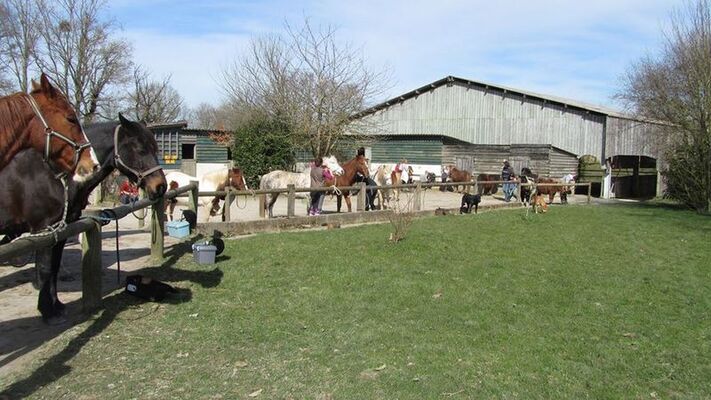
[354,75,637,120]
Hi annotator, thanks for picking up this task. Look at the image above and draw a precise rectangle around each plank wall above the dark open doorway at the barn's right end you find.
[605,116,660,158]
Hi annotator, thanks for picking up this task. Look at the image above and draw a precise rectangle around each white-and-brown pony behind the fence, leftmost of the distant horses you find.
[165,168,247,222]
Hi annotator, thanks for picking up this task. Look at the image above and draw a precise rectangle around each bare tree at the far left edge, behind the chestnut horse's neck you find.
[0,0,43,92]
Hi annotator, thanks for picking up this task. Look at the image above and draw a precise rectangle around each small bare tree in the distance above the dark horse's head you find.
[128,67,183,123]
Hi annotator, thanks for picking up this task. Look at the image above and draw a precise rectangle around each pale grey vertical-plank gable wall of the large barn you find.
[363,82,606,154]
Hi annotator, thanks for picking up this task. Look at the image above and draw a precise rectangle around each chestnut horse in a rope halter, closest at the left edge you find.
[0,74,99,181]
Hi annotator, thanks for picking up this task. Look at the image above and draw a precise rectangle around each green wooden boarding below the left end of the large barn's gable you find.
[370,138,442,165]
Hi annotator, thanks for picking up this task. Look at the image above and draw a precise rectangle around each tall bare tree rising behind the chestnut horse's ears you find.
[37,0,132,122]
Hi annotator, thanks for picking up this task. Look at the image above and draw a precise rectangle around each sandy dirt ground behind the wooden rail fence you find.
[0,190,586,381]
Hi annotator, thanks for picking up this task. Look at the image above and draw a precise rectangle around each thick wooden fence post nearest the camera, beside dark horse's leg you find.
[81,223,102,312]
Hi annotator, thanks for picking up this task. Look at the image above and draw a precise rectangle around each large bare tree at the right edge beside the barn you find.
[618,0,711,213]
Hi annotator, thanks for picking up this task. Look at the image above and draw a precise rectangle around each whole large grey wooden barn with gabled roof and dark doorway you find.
[357,76,661,197]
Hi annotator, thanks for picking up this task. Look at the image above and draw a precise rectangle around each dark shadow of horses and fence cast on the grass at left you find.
[0,236,224,400]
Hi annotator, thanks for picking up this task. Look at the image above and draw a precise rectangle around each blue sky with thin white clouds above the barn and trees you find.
[108,0,682,108]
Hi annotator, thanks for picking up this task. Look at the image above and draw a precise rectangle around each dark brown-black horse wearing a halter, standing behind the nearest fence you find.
[0,114,166,320]
